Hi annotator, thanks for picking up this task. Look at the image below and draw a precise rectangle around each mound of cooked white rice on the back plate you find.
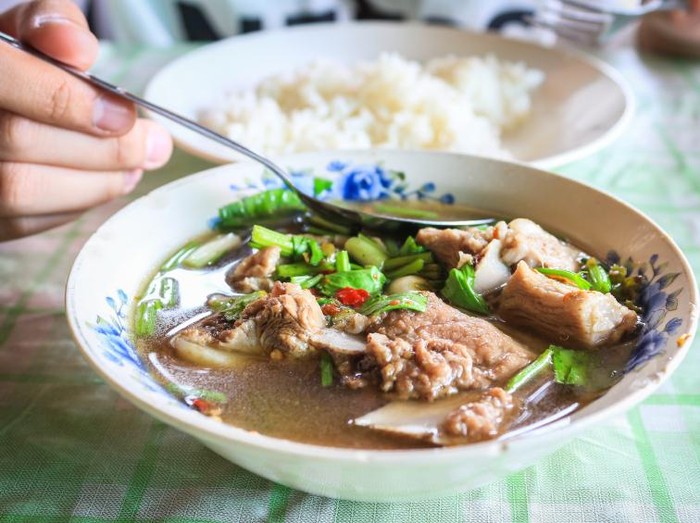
[201,54,544,157]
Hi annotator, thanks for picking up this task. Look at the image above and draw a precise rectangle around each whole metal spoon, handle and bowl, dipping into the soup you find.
[0,32,494,230]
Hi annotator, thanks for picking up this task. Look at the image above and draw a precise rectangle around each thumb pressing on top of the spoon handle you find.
[0,0,99,70]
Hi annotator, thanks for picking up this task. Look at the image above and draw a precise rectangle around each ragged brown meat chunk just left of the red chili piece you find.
[227,282,326,358]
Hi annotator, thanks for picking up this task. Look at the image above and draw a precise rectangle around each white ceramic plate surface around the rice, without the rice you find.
[145,22,633,168]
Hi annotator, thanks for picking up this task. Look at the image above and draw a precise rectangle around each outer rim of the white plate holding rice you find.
[143,20,637,169]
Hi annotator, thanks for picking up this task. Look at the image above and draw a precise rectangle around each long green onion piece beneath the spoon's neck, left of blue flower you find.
[219,188,306,227]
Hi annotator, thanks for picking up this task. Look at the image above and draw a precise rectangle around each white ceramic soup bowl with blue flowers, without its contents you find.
[66,151,697,501]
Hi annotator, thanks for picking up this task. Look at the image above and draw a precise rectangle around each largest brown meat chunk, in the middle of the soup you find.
[367,292,534,400]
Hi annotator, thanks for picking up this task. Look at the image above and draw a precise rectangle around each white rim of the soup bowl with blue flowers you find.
[64,149,699,464]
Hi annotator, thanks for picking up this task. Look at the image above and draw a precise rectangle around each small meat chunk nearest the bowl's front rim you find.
[440,387,513,442]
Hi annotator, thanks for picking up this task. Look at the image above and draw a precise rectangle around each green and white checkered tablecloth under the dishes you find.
[0,42,700,523]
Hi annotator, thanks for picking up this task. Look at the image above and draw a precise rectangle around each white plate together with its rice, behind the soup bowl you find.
[145,22,633,168]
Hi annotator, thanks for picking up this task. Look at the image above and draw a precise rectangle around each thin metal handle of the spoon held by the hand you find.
[0,32,296,192]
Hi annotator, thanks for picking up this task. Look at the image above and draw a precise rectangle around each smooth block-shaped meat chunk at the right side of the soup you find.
[499,261,637,348]
